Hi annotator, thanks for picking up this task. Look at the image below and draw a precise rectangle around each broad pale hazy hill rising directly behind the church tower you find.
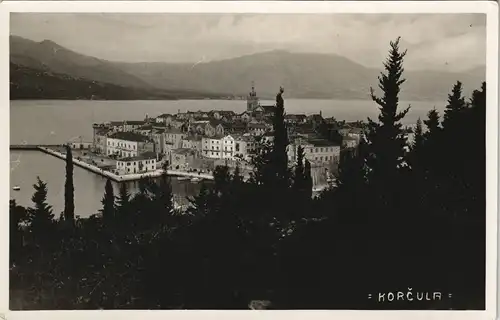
[115,50,486,101]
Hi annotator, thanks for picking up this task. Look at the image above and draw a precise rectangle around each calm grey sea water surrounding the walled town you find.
[10,99,446,217]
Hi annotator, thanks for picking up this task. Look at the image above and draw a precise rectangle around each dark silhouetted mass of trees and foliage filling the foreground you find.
[10,37,486,310]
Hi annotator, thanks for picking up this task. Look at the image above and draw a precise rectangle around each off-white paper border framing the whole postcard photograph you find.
[0,1,499,320]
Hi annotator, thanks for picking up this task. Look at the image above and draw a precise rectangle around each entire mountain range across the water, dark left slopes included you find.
[10,36,486,101]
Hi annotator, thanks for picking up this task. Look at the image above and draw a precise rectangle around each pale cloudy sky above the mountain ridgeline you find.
[10,13,486,71]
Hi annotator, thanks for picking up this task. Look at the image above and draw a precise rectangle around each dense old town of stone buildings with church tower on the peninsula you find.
[93,86,360,181]
